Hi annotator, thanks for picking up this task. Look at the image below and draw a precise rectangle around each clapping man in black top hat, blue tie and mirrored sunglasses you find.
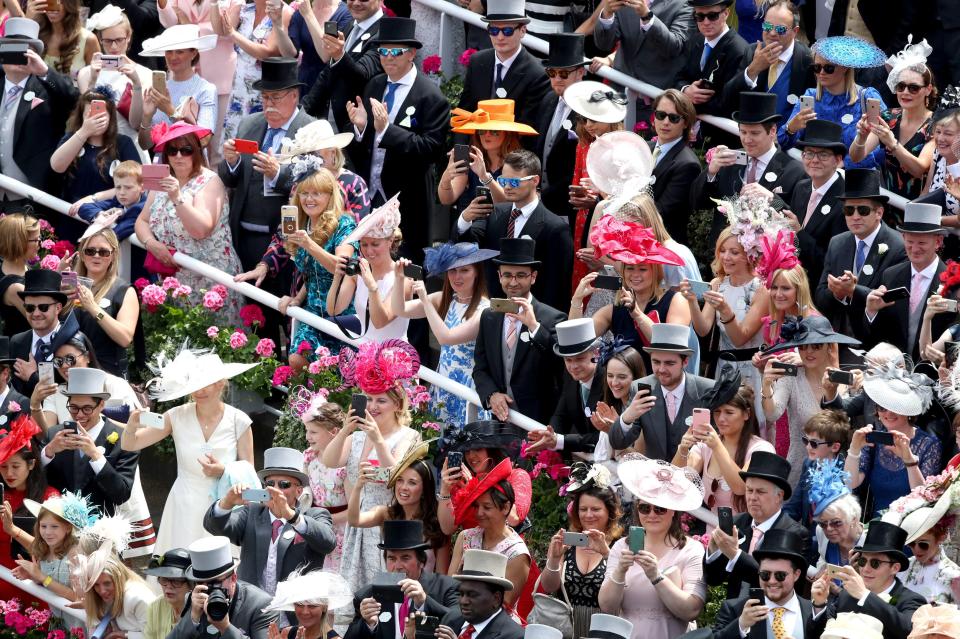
[347,18,450,262]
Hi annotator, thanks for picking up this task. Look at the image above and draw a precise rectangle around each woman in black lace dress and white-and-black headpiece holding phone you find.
[540,462,623,637]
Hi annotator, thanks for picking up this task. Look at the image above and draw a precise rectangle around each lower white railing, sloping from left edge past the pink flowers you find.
[0,175,546,430]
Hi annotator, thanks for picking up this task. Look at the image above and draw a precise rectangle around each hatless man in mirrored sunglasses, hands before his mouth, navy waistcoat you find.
[725,0,816,122]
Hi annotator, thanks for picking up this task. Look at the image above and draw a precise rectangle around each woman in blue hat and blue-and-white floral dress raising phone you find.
[390,242,500,424]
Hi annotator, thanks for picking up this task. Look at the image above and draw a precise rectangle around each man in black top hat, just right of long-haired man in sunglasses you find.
[691,91,803,246]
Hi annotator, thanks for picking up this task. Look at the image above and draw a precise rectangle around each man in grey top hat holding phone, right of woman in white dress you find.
[203,448,336,595]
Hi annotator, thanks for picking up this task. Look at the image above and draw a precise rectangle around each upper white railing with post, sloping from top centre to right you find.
[424,0,909,210]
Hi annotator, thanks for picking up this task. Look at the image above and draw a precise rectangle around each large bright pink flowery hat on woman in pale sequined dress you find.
[340,339,420,395]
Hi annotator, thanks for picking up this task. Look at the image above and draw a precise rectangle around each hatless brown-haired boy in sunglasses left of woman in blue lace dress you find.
[783,410,851,535]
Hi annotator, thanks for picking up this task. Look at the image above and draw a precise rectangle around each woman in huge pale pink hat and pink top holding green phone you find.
[599,459,707,639]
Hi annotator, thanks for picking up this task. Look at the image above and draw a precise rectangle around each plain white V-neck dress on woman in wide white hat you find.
[156,402,251,554]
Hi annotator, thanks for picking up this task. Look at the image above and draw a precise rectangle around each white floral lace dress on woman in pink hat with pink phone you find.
[150,168,244,324]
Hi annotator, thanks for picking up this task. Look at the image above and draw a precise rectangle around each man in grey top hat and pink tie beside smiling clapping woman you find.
[607,323,714,461]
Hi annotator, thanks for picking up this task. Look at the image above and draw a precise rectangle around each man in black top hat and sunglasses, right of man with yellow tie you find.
[805,520,927,639]
